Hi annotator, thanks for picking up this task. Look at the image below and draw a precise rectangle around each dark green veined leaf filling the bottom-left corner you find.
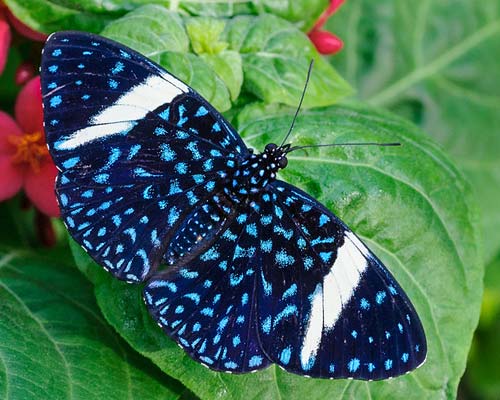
[0,250,183,400]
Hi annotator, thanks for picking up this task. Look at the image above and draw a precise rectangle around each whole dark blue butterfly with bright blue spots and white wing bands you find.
[41,32,426,380]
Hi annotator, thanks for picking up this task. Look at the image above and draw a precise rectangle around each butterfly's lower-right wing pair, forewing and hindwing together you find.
[144,182,426,379]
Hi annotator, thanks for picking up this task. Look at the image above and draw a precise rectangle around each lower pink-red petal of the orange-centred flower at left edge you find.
[24,159,60,217]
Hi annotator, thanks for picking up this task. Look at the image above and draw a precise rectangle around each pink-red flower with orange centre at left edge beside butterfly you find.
[0,76,59,216]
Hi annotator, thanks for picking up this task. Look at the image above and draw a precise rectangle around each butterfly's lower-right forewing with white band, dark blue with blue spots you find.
[255,181,426,380]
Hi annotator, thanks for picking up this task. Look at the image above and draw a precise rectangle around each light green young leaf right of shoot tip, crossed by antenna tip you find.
[226,15,351,107]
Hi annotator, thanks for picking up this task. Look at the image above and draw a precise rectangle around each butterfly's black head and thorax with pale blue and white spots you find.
[228,143,288,197]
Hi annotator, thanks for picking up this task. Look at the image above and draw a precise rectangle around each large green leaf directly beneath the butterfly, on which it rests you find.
[71,106,483,400]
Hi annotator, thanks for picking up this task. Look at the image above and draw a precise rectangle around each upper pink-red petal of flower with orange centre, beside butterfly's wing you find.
[15,76,43,133]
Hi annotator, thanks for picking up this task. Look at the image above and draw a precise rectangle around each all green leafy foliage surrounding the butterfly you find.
[0,0,500,399]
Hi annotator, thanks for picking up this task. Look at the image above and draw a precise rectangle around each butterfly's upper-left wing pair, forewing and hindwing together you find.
[41,32,248,281]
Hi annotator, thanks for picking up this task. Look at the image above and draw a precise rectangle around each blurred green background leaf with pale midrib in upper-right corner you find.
[329,0,500,260]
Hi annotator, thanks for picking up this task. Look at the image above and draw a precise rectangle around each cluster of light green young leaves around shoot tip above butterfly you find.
[102,5,351,111]
